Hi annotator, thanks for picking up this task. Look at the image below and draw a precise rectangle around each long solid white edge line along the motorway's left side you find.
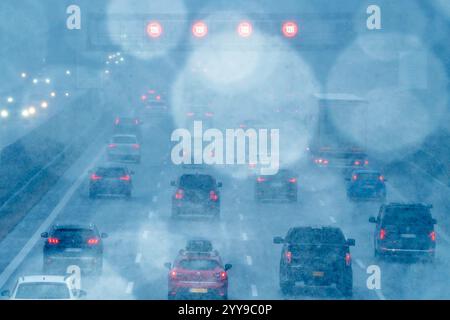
[0,149,104,288]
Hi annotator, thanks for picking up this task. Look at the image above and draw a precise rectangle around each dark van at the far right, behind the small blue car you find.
[369,203,436,262]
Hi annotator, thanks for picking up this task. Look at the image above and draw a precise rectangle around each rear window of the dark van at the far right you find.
[383,207,432,225]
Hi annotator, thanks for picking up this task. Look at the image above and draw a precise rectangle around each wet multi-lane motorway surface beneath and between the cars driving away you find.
[0,114,450,299]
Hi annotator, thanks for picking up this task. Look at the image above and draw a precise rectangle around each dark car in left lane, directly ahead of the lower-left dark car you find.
[89,167,134,198]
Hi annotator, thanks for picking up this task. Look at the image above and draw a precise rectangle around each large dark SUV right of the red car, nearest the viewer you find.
[273,227,355,297]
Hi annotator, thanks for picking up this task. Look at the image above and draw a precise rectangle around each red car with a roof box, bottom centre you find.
[165,241,232,300]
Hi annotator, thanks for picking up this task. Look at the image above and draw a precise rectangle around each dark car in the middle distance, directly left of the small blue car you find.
[255,169,298,202]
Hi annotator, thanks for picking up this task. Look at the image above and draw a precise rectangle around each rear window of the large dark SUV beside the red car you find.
[286,229,345,244]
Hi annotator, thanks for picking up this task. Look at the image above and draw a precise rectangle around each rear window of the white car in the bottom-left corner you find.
[15,282,70,299]
